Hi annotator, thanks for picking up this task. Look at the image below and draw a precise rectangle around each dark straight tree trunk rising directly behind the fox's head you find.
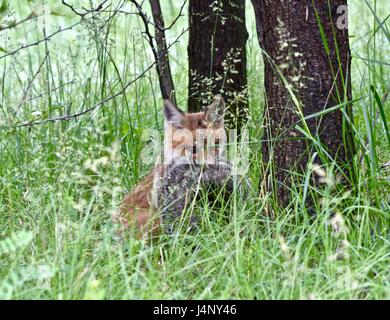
[188,0,248,128]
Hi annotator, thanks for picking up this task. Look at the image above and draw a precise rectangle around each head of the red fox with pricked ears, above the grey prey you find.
[164,95,226,164]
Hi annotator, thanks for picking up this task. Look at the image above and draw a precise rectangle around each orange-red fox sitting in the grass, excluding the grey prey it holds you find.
[115,95,226,239]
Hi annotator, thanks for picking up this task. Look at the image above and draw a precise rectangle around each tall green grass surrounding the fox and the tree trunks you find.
[0,0,390,299]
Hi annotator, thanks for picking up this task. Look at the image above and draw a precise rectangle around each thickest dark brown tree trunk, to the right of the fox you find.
[252,0,354,204]
